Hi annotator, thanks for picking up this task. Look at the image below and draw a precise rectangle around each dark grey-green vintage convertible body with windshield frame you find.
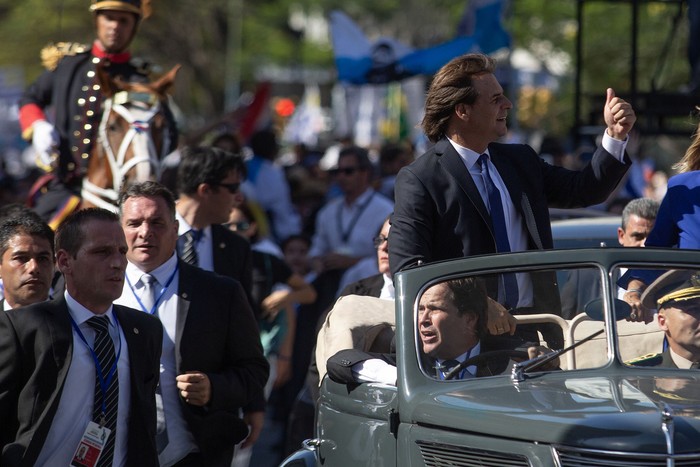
[282,248,700,467]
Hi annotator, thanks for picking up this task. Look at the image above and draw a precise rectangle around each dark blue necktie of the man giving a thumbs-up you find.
[479,154,519,308]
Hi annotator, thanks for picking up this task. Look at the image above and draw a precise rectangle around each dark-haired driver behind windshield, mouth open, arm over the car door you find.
[327,277,558,384]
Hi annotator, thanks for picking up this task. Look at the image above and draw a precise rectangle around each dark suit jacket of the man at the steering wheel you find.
[326,336,534,384]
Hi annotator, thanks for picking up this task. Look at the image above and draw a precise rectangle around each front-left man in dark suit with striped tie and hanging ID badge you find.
[0,209,162,466]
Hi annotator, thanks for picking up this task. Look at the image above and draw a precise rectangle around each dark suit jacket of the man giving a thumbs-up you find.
[389,139,630,274]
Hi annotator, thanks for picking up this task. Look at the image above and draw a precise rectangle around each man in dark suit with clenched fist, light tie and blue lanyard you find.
[119,182,269,466]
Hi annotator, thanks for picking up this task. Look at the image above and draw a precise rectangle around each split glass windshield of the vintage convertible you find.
[415,264,700,381]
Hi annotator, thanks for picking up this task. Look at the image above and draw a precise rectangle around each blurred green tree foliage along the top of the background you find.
[0,0,688,138]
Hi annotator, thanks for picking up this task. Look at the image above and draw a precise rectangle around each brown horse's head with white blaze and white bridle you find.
[79,65,180,212]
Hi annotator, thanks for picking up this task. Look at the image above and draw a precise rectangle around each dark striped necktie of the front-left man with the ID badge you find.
[87,316,119,467]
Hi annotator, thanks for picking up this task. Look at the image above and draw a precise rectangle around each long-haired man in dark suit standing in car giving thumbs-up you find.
[389,54,636,348]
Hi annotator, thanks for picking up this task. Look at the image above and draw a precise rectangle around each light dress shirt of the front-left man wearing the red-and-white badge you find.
[34,291,131,467]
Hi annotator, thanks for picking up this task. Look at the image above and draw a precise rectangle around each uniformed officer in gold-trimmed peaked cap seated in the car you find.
[628,270,700,369]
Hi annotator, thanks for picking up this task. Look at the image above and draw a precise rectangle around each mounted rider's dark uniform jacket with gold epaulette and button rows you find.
[19,42,178,226]
